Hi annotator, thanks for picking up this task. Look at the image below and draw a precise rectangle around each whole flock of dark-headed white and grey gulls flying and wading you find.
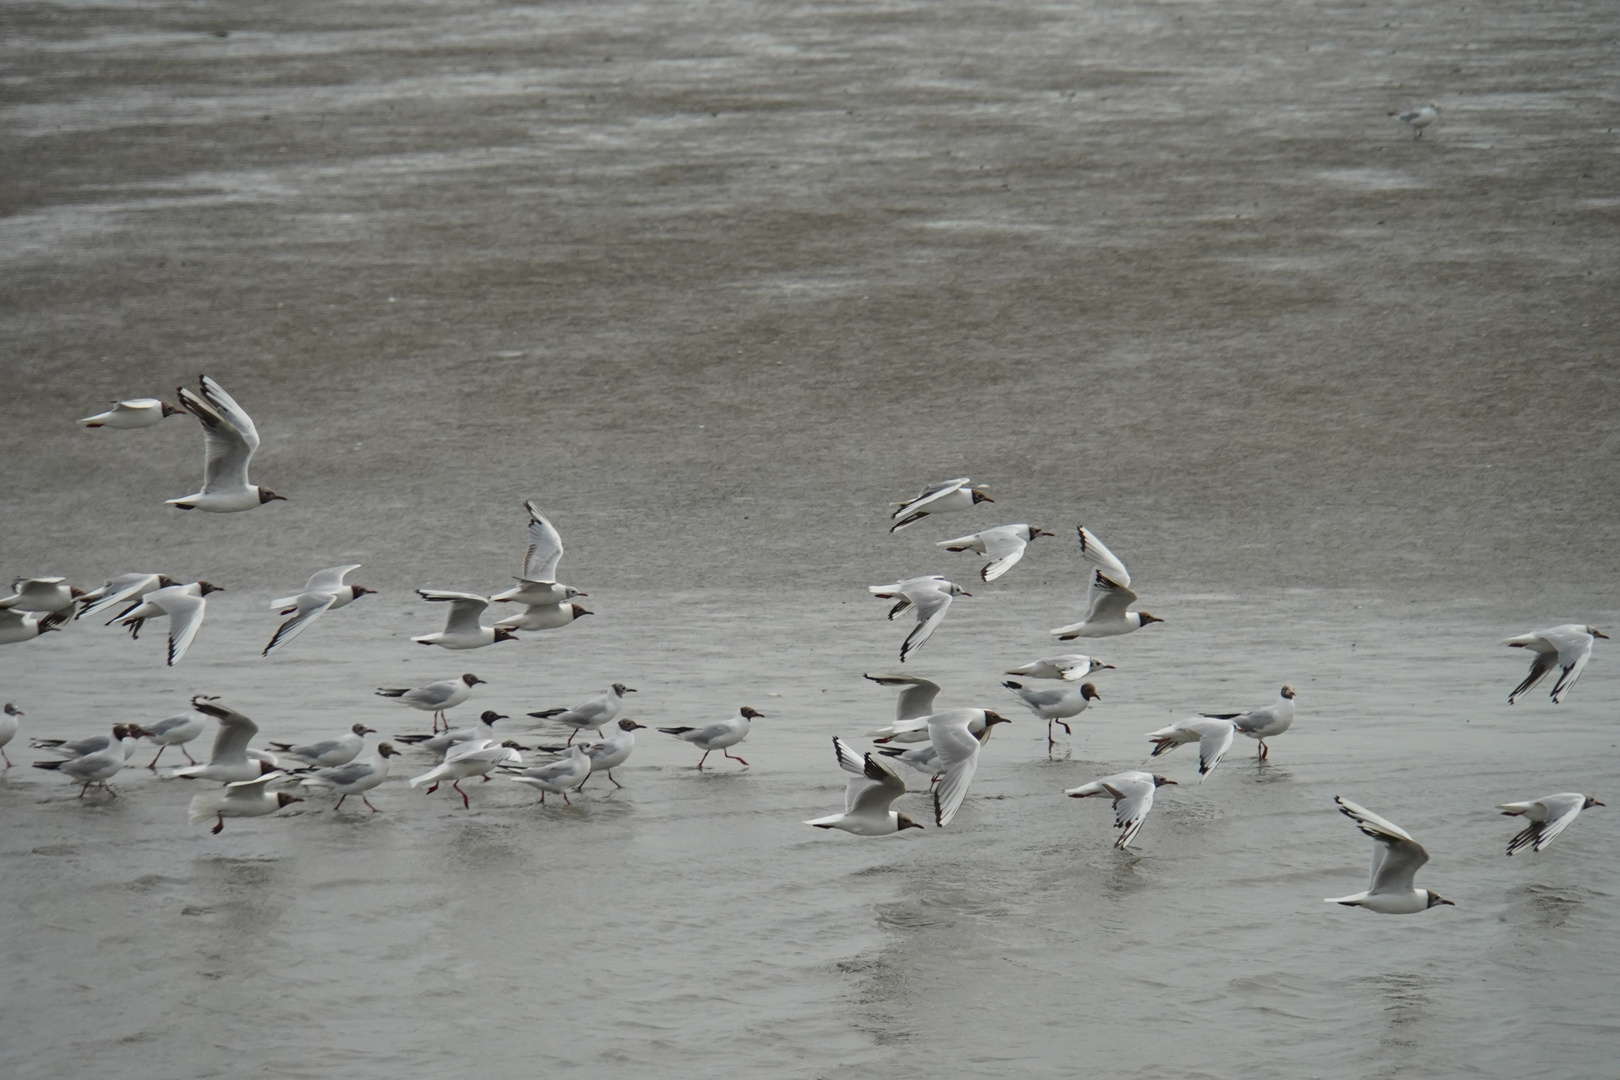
[0,375,1605,915]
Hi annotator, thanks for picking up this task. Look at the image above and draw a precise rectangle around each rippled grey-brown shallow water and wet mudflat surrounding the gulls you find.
[0,2,1620,1078]
